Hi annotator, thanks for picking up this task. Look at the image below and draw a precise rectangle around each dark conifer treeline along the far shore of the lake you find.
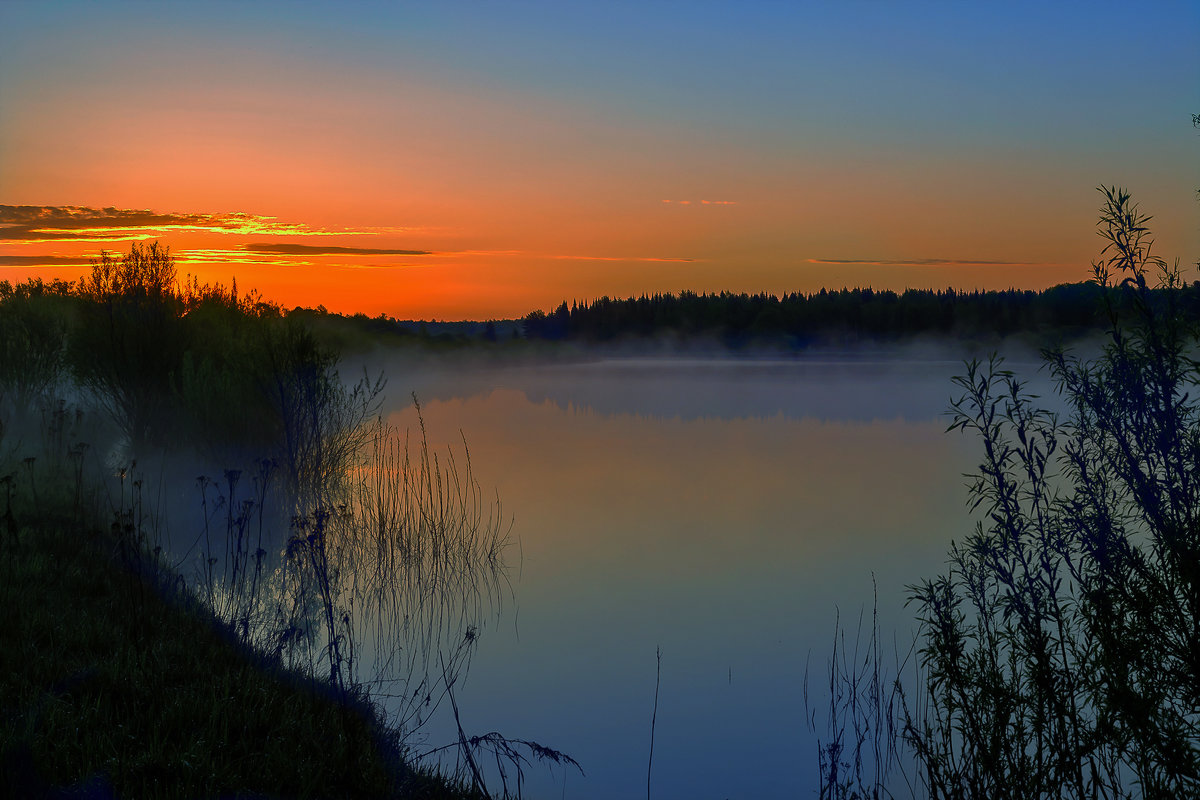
[201,281,1200,351]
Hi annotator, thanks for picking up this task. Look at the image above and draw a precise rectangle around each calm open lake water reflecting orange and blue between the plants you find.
[374,359,1033,799]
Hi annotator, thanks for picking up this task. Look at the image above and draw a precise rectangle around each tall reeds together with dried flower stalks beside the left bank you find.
[186,407,509,733]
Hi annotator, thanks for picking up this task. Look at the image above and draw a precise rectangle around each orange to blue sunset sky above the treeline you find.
[0,0,1200,320]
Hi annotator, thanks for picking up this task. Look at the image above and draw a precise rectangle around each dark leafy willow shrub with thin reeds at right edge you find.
[820,188,1200,800]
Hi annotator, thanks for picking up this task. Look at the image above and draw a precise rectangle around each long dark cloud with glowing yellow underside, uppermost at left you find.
[0,205,407,242]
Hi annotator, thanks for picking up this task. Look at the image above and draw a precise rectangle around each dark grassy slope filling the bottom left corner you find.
[0,510,470,798]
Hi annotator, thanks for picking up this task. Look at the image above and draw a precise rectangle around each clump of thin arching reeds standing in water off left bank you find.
[272,407,508,732]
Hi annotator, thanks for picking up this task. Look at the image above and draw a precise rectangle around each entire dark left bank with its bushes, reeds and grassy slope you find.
[0,245,574,798]
